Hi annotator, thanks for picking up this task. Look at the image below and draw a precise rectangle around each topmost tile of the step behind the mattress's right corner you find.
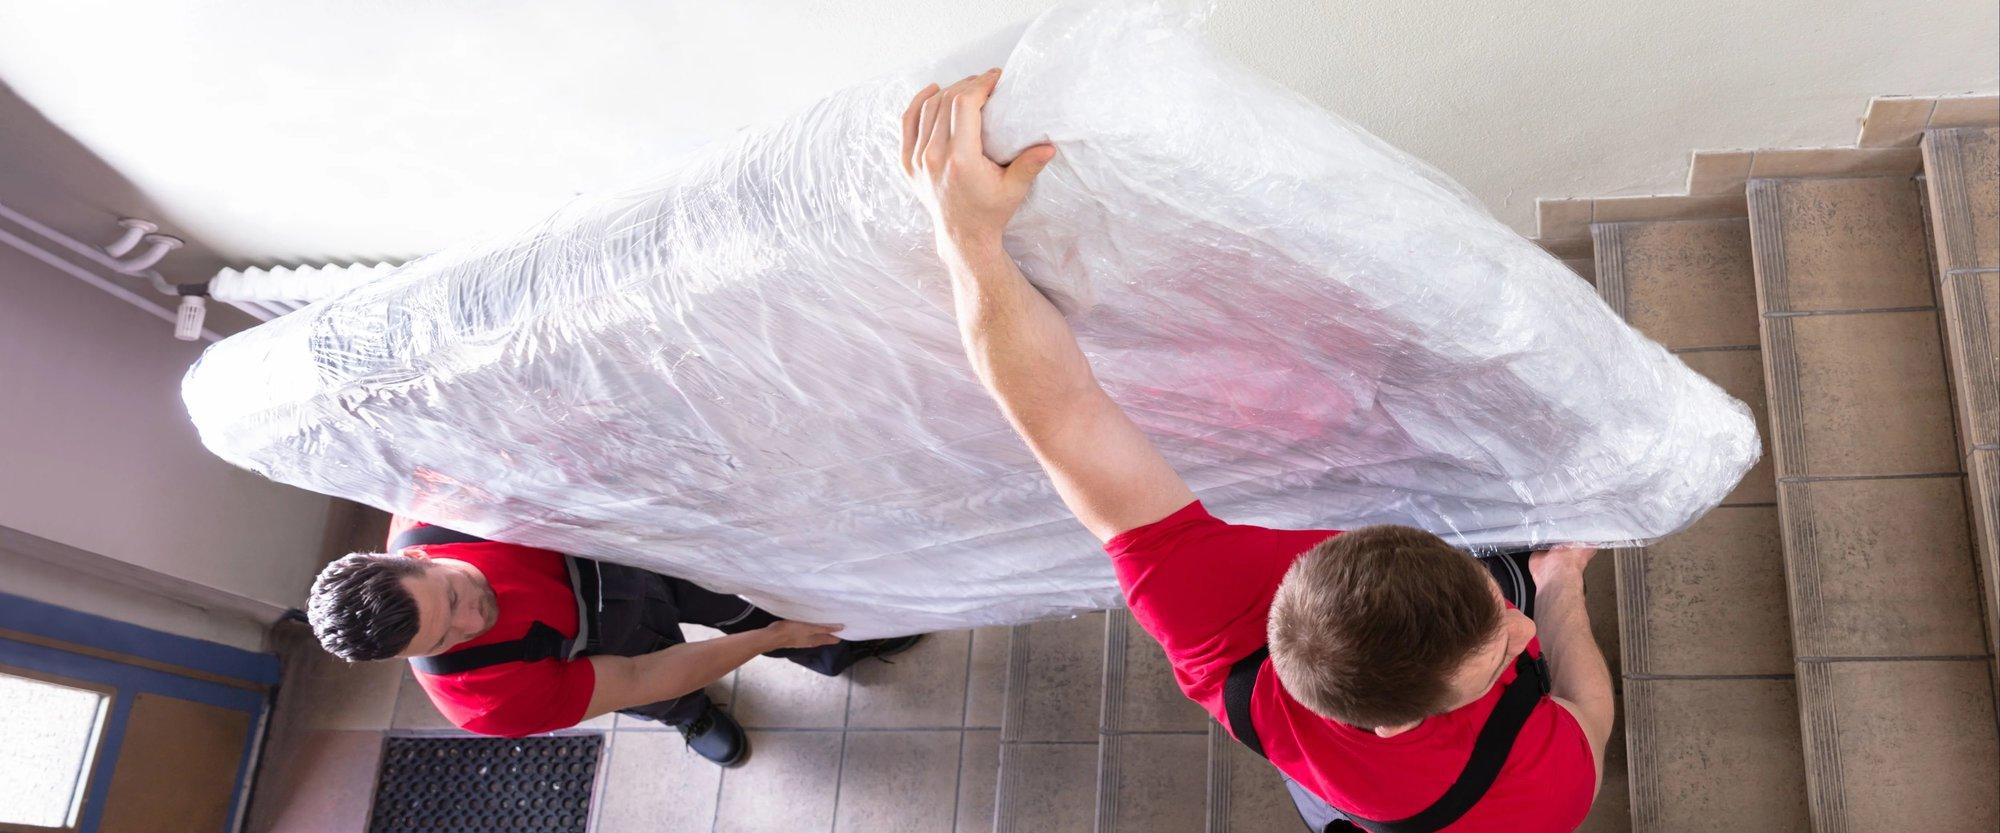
[1608,220,1758,350]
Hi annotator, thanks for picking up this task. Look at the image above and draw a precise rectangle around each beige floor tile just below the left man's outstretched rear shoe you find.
[848,631,972,729]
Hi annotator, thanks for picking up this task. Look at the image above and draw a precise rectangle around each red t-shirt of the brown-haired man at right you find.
[1104,501,1596,833]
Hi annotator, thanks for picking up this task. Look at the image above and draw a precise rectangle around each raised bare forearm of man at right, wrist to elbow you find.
[946,242,1102,436]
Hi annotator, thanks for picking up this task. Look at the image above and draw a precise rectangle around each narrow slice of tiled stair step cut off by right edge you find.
[1924,126,2000,676]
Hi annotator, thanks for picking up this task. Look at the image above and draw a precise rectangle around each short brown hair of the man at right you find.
[1268,525,1502,729]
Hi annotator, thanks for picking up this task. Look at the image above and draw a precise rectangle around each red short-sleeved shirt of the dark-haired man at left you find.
[410,543,598,737]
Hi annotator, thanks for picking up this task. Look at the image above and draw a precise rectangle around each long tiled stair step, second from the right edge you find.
[1748,176,2000,831]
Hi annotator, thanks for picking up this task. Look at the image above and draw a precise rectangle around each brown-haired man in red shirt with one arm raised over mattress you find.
[902,70,1612,833]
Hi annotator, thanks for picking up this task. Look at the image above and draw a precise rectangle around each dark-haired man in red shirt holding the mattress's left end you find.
[306,517,920,767]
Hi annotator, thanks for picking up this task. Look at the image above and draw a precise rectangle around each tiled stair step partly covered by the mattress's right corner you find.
[1586,218,1808,833]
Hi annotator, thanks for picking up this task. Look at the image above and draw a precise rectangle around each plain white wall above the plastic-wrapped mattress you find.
[0,0,2000,272]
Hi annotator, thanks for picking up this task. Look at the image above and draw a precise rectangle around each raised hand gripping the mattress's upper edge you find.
[902,68,1056,256]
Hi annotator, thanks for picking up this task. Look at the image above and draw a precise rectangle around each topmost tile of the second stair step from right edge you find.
[1752,178,1932,312]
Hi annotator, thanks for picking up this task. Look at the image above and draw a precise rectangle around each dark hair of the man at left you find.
[306,553,428,663]
